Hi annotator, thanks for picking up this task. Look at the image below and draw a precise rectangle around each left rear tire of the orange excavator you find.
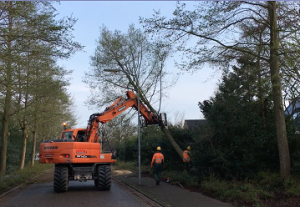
[53,166,69,193]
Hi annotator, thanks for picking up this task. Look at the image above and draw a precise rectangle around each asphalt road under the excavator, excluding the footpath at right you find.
[0,181,148,207]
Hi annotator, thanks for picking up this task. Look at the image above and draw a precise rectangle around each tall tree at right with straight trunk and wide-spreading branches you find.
[141,1,300,178]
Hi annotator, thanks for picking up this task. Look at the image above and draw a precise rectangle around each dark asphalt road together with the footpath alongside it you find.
[0,168,232,207]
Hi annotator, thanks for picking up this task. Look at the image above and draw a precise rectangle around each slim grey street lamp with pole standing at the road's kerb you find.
[103,69,141,185]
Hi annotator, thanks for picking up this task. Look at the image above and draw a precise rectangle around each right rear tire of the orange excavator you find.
[97,165,111,190]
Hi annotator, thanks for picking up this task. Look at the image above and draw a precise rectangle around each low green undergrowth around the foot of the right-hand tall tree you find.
[201,172,300,207]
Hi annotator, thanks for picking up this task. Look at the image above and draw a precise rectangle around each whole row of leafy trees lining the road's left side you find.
[0,1,82,174]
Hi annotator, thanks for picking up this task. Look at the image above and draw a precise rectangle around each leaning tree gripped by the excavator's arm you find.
[85,25,182,157]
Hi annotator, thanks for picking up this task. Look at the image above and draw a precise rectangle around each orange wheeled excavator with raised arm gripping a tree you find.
[39,91,164,192]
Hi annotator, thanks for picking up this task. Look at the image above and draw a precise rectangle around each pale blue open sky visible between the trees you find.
[55,1,218,128]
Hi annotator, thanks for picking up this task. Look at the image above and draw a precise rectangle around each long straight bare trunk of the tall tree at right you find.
[268,1,291,179]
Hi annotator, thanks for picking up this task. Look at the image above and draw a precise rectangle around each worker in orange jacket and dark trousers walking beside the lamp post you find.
[151,146,165,185]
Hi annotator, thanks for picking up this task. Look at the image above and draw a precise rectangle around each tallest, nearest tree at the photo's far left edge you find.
[0,1,82,174]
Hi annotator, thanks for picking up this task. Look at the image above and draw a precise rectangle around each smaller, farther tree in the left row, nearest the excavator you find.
[27,55,74,165]
